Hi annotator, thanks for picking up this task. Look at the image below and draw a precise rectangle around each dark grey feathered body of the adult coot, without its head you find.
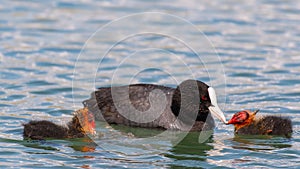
[83,84,176,128]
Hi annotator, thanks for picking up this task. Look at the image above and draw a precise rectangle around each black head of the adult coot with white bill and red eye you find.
[171,80,227,123]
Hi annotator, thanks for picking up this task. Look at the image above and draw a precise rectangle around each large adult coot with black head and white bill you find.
[83,80,227,131]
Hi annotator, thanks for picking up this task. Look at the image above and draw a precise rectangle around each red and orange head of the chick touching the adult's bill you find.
[227,110,259,129]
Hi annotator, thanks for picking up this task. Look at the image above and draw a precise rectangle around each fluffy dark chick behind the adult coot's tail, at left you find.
[23,108,95,140]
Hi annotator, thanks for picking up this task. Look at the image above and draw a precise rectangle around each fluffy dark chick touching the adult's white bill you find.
[228,110,293,137]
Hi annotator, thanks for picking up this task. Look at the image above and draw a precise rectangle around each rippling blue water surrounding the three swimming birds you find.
[0,0,300,168]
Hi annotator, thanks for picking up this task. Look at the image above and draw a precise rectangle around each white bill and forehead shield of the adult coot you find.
[208,87,227,124]
